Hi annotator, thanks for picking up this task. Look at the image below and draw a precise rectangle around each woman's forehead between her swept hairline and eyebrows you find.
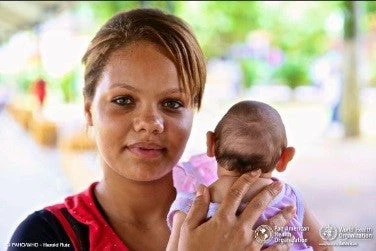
[99,42,185,92]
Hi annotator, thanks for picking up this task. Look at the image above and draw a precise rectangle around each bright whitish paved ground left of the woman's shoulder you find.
[0,111,71,250]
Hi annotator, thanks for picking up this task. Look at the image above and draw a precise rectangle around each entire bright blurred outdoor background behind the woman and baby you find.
[0,1,376,250]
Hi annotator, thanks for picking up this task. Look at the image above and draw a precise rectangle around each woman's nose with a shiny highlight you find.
[133,108,164,134]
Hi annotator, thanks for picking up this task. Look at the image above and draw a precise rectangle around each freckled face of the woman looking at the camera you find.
[85,41,193,181]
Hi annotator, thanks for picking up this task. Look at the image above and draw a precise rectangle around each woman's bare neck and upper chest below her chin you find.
[95,169,176,228]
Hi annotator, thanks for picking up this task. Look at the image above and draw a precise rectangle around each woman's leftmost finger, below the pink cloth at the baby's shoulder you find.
[183,185,210,229]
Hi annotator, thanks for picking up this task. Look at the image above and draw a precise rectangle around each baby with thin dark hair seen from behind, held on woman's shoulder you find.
[167,101,327,250]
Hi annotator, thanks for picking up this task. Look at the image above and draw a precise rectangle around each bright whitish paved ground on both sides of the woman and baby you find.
[0,99,376,250]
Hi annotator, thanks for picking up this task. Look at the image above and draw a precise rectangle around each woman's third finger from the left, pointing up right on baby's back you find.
[240,181,283,226]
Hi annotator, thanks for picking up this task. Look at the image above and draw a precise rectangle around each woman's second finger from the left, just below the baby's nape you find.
[217,169,261,216]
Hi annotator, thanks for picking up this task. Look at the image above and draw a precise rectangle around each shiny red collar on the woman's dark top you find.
[64,182,128,251]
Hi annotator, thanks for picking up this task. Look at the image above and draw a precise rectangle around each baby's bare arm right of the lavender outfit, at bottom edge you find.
[303,207,333,251]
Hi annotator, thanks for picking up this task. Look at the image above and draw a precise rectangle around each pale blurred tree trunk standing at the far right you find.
[341,1,360,138]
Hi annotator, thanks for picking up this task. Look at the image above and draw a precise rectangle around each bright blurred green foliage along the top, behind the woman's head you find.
[75,1,342,58]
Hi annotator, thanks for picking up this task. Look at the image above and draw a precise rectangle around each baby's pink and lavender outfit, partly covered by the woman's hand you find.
[167,154,313,251]
